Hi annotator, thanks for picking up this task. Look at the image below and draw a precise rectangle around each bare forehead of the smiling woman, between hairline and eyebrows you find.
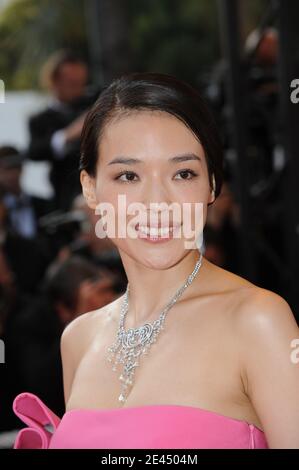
[99,111,203,161]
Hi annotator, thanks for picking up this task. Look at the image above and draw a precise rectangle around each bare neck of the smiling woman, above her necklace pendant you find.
[120,249,204,329]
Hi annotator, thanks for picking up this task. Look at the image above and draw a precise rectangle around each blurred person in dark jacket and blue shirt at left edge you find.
[0,146,53,295]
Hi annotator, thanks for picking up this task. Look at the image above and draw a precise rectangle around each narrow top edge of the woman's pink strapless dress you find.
[62,404,265,435]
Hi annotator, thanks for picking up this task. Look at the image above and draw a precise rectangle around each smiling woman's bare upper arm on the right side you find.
[238,288,299,448]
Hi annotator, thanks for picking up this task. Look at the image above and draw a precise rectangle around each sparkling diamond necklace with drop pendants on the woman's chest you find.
[107,253,202,403]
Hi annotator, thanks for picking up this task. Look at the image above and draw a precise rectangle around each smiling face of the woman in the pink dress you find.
[81,111,213,268]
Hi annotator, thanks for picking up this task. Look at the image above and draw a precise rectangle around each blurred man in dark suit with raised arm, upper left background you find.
[28,51,99,210]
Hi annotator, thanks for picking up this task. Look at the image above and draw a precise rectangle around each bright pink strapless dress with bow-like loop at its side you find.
[13,393,268,449]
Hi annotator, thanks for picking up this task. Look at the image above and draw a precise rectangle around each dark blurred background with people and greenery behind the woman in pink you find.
[0,0,299,448]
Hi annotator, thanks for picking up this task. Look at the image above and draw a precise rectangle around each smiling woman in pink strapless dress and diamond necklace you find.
[14,73,299,448]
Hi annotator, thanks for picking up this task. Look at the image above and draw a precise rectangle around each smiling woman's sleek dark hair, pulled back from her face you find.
[79,72,223,197]
